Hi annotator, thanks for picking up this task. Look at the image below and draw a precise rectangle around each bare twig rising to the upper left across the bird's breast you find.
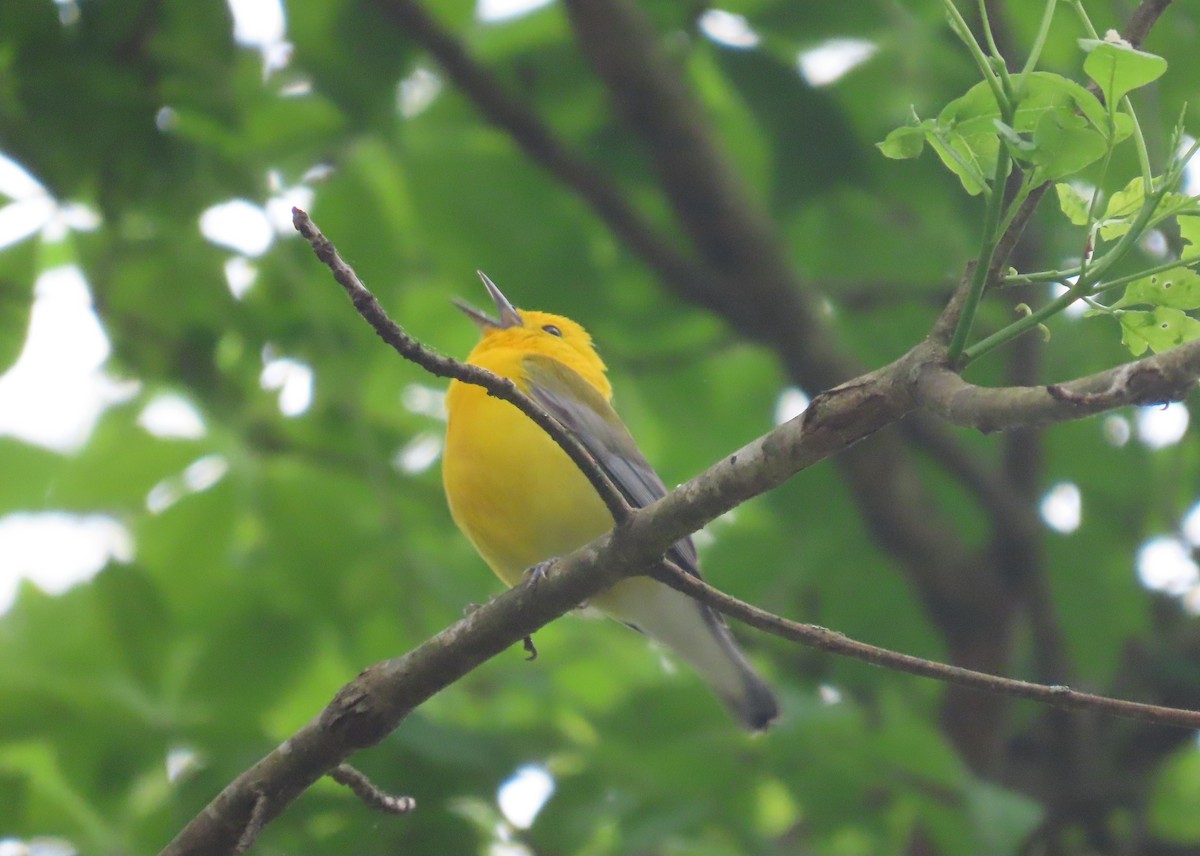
[292,208,631,522]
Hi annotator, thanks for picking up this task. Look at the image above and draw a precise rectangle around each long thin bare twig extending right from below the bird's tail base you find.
[654,562,1200,729]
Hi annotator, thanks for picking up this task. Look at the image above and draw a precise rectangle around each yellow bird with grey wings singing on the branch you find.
[442,273,779,731]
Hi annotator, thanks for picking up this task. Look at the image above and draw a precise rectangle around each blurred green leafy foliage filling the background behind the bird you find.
[0,0,1200,856]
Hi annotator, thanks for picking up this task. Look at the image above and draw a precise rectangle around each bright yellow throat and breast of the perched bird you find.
[442,349,612,586]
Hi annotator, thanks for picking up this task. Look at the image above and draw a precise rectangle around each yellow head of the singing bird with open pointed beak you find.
[455,271,607,389]
